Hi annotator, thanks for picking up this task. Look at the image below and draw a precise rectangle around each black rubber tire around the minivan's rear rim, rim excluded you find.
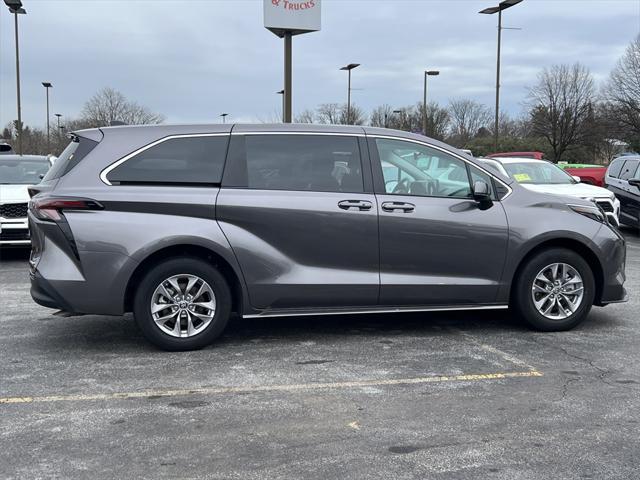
[133,257,231,351]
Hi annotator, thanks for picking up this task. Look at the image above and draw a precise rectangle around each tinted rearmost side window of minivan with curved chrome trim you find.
[107,135,229,188]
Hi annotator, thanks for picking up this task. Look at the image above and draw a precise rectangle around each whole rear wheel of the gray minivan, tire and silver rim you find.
[133,258,231,351]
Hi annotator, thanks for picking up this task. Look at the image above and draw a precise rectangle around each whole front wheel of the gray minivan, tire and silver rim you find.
[512,248,595,332]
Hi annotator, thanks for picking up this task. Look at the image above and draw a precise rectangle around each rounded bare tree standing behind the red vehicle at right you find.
[529,63,595,162]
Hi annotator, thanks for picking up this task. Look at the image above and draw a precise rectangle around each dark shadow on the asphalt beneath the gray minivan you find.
[33,310,624,354]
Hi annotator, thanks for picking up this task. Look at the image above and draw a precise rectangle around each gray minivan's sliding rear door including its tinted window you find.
[216,133,379,309]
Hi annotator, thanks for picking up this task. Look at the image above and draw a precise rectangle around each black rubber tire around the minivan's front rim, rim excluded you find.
[511,248,596,332]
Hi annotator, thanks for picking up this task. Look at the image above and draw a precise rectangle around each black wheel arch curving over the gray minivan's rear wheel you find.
[123,243,246,314]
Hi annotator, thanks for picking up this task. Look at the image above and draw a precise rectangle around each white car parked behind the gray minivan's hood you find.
[480,157,620,227]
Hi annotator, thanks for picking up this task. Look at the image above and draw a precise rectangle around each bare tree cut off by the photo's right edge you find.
[603,35,640,148]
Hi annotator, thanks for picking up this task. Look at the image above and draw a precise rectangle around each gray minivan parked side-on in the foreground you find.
[29,124,626,350]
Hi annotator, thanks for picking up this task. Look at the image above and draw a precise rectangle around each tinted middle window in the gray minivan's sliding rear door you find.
[245,135,364,193]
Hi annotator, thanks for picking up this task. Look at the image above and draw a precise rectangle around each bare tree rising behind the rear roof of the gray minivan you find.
[81,87,164,127]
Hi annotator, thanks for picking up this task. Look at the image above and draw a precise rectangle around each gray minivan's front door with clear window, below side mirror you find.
[369,138,508,305]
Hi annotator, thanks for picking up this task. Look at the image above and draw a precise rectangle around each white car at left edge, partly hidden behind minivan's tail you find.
[0,155,52,247]
